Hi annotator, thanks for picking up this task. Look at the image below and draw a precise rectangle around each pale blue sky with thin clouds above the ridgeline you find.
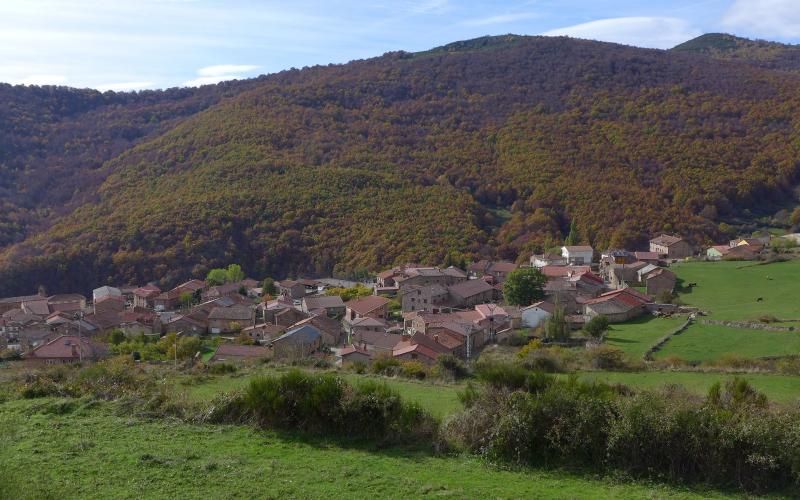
[0,0,800,90]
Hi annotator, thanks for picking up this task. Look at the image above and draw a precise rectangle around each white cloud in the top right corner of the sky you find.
[722,0,800,38]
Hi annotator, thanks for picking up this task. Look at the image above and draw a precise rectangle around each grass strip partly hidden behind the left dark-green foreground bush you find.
[178,370,462,417]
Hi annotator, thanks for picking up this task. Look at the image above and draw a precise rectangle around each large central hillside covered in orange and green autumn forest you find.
[0,37,800,294]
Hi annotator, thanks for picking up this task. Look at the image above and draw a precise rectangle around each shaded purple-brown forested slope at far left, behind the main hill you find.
[0,80,266,248]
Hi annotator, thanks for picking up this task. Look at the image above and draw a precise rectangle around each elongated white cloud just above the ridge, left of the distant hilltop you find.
[542,17,702,49]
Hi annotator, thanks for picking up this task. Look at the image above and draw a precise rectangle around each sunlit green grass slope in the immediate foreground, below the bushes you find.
[0,400,736,499]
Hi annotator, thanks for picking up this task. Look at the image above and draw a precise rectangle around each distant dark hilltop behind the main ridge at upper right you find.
[672,33,800,71]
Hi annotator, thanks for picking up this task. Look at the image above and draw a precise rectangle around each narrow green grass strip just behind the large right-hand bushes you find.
[578,371,800,404]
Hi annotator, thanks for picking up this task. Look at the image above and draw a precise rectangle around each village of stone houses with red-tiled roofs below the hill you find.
[0,234,793,365]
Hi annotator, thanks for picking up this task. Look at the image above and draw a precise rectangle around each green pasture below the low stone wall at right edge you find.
[655,323,800,361]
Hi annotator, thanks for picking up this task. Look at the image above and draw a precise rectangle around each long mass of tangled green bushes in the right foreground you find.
[442,377,800,492]
